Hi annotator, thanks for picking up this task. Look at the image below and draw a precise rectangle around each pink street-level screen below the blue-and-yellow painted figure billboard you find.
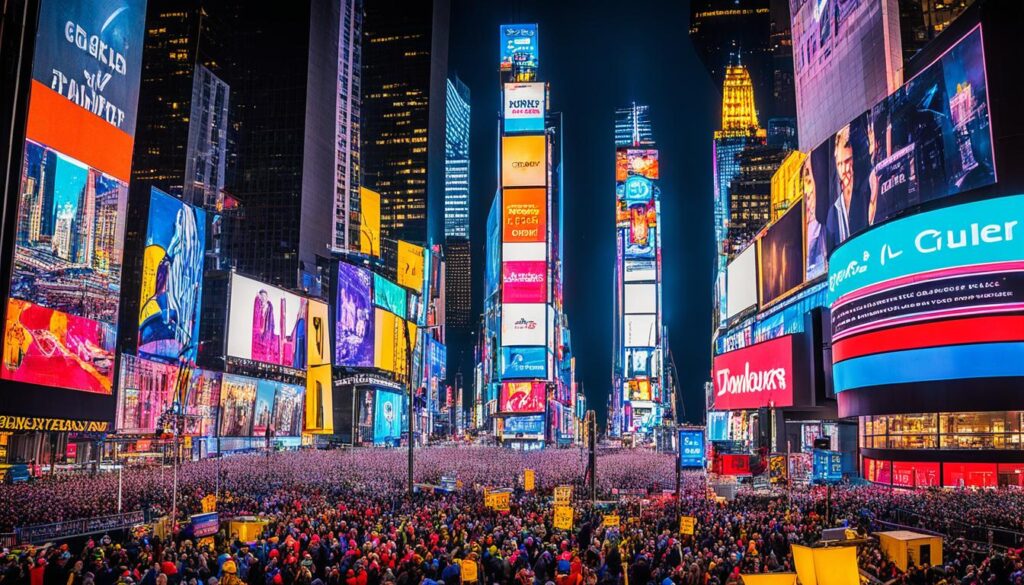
[115,354,178,434]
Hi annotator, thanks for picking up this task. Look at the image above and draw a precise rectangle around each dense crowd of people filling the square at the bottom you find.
[0,447,1024,585]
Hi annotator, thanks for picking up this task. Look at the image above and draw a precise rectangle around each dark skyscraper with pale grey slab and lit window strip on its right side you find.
[227,0,362,288]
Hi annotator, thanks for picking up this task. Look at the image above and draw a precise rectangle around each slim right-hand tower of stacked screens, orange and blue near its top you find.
[611,103,672,435]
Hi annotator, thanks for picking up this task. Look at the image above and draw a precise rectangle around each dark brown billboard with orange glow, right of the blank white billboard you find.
[757,203,805,308]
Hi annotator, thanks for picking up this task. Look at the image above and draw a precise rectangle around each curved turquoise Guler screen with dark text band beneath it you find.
[828,196,1024,339]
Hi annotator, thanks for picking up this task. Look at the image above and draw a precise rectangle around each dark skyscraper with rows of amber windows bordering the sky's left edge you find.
[361,0,451,244]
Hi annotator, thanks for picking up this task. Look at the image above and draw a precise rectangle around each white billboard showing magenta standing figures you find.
[227,274,307,370]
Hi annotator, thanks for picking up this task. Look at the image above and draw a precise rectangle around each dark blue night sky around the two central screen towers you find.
[449,0,721,426]
